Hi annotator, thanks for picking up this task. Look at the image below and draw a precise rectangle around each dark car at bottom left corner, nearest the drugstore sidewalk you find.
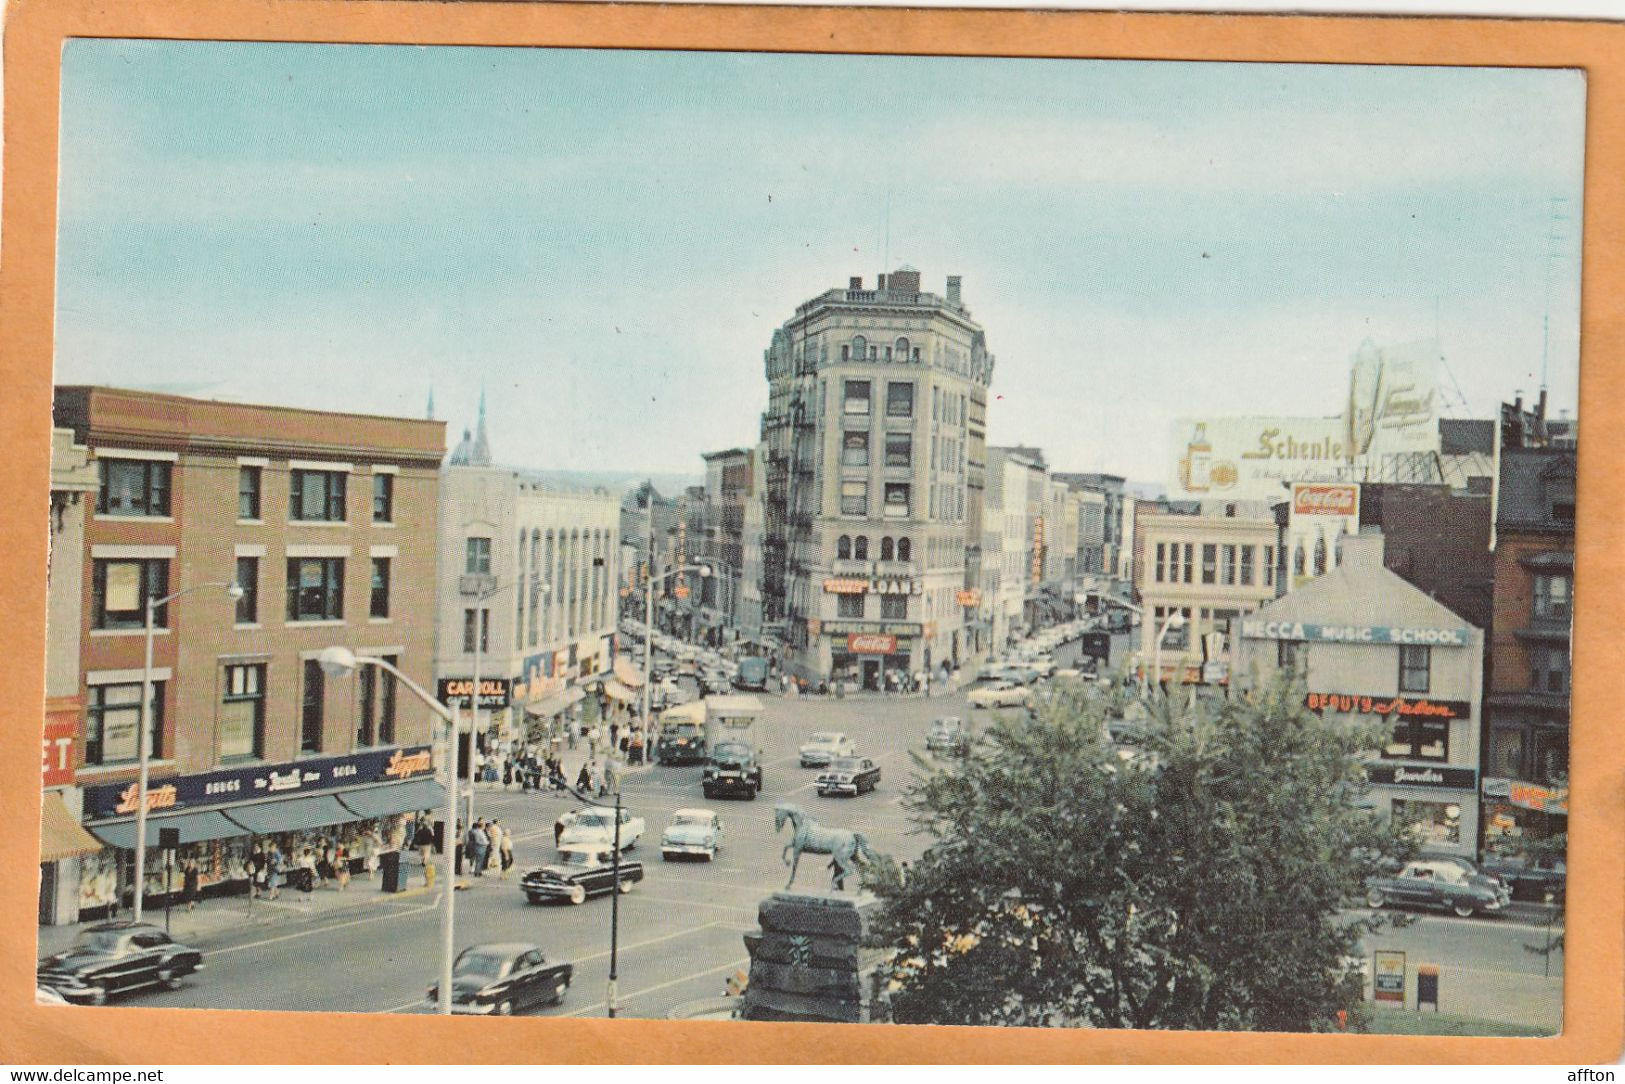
[37,921,203,1004]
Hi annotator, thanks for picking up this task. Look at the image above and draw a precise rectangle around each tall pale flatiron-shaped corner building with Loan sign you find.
[761,268,993,687]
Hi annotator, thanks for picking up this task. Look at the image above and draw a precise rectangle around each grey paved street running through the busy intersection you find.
[63,656,1562,1027]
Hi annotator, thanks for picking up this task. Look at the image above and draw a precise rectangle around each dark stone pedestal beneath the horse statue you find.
[739,892,884,1024]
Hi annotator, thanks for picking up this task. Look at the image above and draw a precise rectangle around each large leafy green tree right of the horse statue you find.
[869,678,1414,1030]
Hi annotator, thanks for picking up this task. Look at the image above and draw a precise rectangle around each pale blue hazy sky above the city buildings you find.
[55,39,1584,481]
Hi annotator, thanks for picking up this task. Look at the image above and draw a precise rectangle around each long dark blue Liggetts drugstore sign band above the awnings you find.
[85,746,434,821]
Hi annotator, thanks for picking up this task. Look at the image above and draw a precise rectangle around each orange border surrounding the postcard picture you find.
[0,0,1625,1064]
